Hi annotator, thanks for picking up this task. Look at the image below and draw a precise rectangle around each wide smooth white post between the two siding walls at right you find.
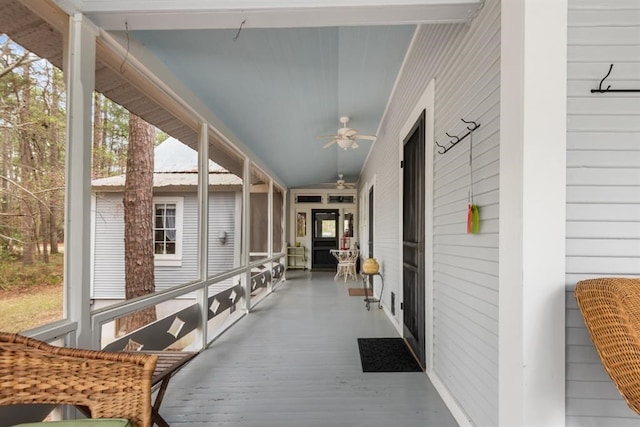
[498,0,567,426]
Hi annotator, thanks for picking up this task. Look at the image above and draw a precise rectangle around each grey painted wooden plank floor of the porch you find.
[160,271,457,427]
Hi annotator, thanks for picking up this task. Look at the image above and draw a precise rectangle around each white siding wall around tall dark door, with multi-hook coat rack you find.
[360,0,500,426]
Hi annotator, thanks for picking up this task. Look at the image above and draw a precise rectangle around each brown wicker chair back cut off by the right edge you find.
[575,277,640,414]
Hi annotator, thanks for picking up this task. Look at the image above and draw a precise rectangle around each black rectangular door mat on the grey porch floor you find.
[358,338,423,372]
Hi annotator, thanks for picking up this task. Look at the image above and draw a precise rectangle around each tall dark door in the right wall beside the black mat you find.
[402,111,426,367]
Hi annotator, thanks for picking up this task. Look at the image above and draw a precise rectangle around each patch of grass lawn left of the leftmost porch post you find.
[0,254,62,332]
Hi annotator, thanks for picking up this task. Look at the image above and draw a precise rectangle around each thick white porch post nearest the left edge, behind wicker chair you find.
[64,13,98,348]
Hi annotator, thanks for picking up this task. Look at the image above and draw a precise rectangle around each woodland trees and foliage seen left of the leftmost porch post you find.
[0,35,66,264]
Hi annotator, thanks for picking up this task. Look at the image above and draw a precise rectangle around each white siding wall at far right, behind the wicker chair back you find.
[566,0,640,427]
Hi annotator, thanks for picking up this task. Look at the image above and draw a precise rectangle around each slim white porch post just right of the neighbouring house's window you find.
[194,123,209,349]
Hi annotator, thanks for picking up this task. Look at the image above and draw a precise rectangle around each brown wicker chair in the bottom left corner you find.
[0,332,157,427]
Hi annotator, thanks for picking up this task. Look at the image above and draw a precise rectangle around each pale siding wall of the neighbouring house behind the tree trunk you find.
[92,192,236,299]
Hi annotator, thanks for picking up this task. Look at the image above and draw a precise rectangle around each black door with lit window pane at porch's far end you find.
[311,209,339,270]
